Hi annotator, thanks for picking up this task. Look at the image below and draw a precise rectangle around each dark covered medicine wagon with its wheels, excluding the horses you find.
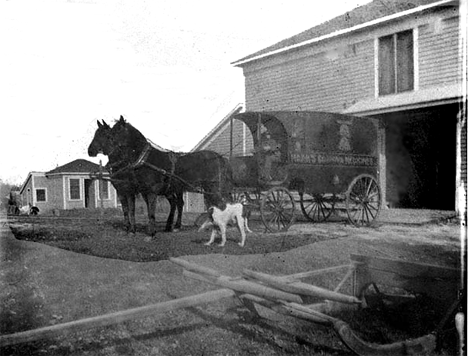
[230,111,382,231]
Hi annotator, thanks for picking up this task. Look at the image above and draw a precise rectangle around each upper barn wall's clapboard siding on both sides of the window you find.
[243,9,462,112]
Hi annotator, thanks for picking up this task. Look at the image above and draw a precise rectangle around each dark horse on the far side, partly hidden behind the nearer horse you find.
[88,120,184,233]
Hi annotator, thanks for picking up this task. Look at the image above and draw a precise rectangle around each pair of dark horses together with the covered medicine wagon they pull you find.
[88,111,382,235]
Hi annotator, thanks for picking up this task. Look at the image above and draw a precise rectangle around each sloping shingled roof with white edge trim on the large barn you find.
[232,0,458,66]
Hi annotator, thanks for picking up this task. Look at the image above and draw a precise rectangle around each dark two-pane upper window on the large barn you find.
[379,30,414,95]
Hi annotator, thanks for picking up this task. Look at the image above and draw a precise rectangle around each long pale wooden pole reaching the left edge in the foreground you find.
[0,289,235,347]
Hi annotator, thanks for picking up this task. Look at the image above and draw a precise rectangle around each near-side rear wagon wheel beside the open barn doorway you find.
[346,174,382,226]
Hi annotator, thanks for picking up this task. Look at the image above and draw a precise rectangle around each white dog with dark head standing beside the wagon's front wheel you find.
[198,203,252,247]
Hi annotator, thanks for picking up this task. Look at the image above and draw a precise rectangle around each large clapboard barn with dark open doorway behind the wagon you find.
[196,0,466,210]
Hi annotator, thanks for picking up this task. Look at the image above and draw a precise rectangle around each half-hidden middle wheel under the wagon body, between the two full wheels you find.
[300,193,336,222]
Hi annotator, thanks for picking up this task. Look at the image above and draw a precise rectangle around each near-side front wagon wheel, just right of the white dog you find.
[260,187,295,232]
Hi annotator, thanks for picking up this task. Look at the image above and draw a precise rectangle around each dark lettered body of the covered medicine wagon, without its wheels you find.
[231,111,378,193]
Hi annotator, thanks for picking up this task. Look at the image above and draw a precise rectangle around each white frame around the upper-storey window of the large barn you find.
[374,27,419,98]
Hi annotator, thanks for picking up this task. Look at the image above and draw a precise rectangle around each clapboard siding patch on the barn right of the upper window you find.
[418,16,462,89]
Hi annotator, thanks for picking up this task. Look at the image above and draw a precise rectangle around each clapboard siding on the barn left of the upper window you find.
[246,40,375,112]
